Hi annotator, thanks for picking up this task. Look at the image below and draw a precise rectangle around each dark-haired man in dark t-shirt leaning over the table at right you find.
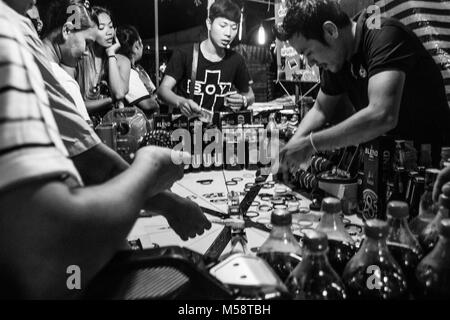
[277,0,450,171]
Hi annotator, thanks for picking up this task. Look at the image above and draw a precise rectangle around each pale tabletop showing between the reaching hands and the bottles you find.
[128,170,362,255]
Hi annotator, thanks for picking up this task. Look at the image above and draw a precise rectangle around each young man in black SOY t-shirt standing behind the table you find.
[158,0,255,117]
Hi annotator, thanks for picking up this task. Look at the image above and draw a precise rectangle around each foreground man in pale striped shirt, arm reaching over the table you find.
[0,0,209,298]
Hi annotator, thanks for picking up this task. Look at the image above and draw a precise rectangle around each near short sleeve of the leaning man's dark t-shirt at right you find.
[367,25,417,78]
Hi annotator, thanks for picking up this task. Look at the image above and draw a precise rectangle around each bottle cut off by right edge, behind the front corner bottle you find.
[419,184,450,254]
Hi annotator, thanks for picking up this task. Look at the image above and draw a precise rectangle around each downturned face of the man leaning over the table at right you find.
[289,24,345,72]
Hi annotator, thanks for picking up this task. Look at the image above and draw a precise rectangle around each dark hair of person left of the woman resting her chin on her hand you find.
[43,0,94,37]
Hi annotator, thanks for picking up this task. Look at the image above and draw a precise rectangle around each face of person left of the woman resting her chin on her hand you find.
[61,27,98,67]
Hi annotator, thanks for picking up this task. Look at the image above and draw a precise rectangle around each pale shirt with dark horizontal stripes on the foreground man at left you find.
[0,0,82,192]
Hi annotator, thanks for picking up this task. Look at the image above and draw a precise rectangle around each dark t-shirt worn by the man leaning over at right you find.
[321,13,450,145]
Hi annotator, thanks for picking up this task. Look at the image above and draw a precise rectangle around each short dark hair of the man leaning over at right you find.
[275,0,351,44]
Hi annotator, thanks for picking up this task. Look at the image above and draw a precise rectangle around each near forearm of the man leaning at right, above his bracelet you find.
[313,107,392,151]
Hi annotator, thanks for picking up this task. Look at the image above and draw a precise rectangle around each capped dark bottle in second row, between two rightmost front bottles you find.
[387,201,423,291]
